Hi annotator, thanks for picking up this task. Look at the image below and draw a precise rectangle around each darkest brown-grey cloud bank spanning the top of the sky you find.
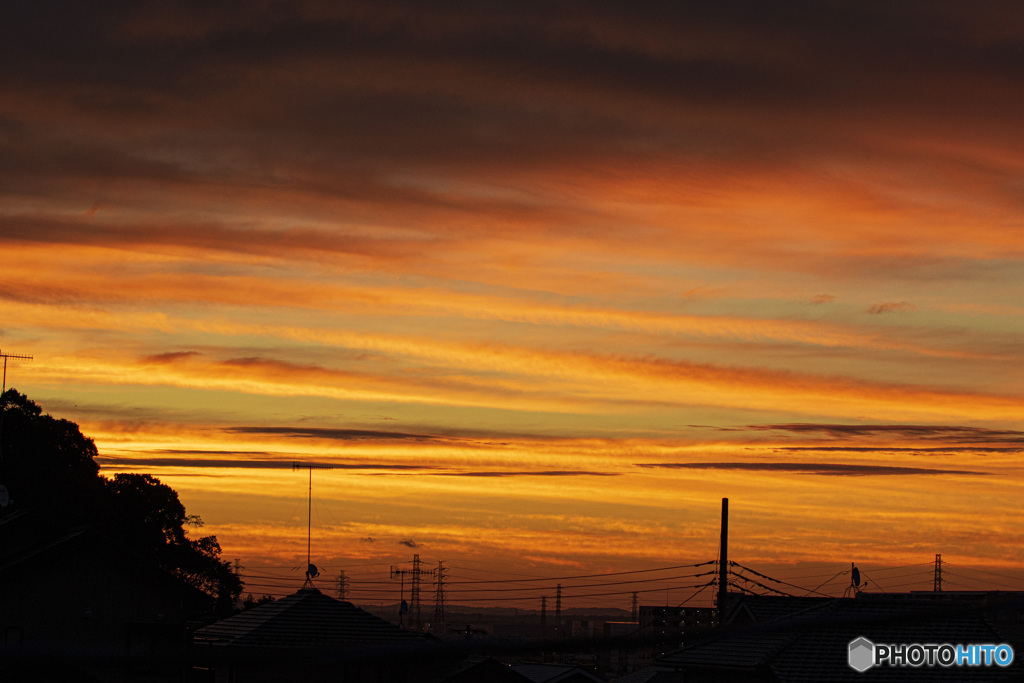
[6,0,1024,197]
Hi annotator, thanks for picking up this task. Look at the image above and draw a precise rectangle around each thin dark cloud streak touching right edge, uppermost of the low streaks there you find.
[746,423,1024,447]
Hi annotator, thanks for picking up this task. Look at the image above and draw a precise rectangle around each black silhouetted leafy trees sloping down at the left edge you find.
[0,389,242,611]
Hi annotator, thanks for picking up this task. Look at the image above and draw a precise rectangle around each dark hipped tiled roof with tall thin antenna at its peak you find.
[195,588,421,649]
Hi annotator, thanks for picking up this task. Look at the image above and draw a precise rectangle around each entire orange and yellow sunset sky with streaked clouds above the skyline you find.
[0,0,1024,604]
